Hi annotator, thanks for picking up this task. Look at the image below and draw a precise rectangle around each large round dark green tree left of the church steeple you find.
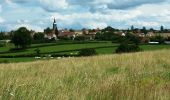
[12,27,32,49]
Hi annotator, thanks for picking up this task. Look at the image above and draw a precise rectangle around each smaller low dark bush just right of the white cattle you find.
[79,48,97,56]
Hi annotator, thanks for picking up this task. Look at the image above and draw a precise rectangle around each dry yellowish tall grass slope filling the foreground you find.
[0,50,170,100]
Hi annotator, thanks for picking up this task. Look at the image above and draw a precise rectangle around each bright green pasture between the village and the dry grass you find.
[0,41,170,62]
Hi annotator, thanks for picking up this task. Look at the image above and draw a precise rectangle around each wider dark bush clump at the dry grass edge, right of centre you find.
[116,43,141,53]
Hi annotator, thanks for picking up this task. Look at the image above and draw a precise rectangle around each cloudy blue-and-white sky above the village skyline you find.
[0,0,170,31]
